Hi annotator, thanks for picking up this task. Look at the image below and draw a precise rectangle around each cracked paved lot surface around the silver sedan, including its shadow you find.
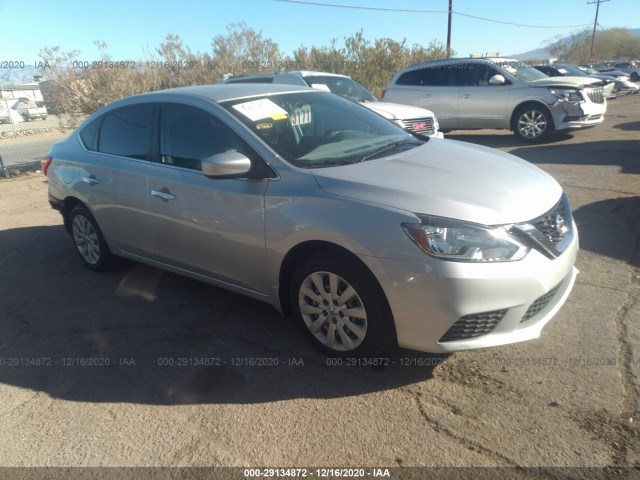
[0,91,640,478]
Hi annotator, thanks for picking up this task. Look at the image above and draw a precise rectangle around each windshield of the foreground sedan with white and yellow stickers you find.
[222,92,425,168]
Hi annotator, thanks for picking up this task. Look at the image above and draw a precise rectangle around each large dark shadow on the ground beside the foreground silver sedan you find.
[0,226,446,405]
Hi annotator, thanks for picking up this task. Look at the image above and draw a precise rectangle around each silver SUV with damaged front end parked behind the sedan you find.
[382,58,607,142]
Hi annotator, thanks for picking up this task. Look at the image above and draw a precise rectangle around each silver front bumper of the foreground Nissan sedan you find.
[363,220,578,353]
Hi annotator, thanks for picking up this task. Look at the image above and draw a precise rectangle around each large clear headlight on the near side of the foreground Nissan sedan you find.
[402,215,529,262]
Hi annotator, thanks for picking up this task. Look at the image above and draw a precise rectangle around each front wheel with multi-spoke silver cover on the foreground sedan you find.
[290,251,395,358]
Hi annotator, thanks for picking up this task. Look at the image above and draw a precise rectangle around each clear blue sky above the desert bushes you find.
[0,0,640,67]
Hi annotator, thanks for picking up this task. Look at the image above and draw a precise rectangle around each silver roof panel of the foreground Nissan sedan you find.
[130,83,317,102]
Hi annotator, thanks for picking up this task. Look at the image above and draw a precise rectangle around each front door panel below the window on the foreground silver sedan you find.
[149,164,268,293]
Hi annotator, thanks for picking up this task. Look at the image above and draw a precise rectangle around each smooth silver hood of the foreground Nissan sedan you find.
[313,139,562,225]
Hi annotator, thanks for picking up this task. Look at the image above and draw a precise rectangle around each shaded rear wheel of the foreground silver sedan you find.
[69,205,114,271]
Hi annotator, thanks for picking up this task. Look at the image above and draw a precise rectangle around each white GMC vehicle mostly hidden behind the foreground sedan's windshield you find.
[223,70,443,138]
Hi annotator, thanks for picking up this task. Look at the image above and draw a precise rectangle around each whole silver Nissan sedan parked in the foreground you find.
[43,84,578,357]
